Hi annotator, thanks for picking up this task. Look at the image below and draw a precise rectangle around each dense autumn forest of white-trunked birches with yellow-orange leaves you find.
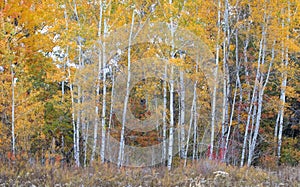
[0,0,300,184]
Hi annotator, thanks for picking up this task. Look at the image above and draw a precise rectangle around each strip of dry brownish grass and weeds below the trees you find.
[0,160,300,187]
